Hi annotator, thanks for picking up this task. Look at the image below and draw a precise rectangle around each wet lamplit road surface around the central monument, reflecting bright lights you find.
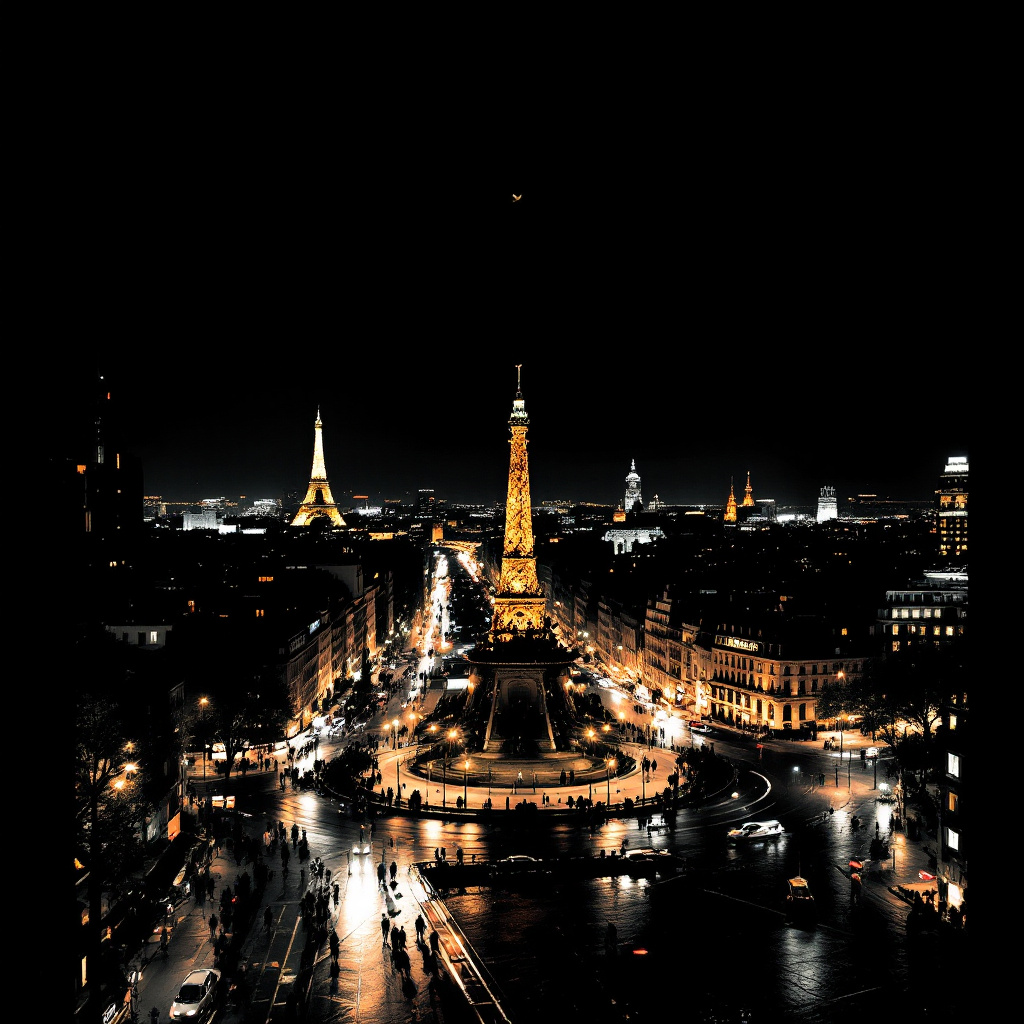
[137,557,949,1024]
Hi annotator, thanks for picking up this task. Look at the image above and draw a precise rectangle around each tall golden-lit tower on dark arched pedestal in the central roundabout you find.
[467,365,579,757]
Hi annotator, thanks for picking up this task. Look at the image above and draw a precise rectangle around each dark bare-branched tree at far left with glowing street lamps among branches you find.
[74,694,147,1021]
